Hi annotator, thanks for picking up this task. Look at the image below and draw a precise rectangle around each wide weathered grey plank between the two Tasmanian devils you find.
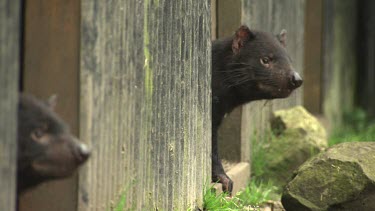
[79,0,211,210]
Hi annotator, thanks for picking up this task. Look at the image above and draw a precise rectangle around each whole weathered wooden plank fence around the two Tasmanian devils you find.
[0,0,375,211]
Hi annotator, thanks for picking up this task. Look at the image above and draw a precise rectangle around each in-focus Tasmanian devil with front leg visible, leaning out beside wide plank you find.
[212,26,302,194]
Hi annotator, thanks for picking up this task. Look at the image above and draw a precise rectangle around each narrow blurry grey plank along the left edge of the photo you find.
[0,0,21,211]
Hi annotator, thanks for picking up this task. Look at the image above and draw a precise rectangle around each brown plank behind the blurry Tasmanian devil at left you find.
[19,0,80,211]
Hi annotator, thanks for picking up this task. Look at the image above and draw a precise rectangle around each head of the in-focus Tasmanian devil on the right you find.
[226,26,302,100]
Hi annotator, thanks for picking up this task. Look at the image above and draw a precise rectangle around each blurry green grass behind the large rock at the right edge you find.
[328,108,375,146]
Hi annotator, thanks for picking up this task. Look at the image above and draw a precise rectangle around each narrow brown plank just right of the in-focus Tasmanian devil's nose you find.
[303,0,323,114]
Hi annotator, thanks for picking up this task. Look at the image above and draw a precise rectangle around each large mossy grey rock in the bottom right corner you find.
[282,142,375,211]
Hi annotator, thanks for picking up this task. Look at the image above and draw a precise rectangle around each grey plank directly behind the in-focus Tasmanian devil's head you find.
[241,0,305,150]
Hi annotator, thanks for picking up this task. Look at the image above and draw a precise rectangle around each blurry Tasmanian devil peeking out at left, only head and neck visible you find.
[17,94,90,194]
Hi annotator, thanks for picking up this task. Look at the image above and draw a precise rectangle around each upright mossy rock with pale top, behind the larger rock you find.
[265,106,327,185]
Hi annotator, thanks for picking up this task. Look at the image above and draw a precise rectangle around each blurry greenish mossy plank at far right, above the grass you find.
[323,0,357,126]
